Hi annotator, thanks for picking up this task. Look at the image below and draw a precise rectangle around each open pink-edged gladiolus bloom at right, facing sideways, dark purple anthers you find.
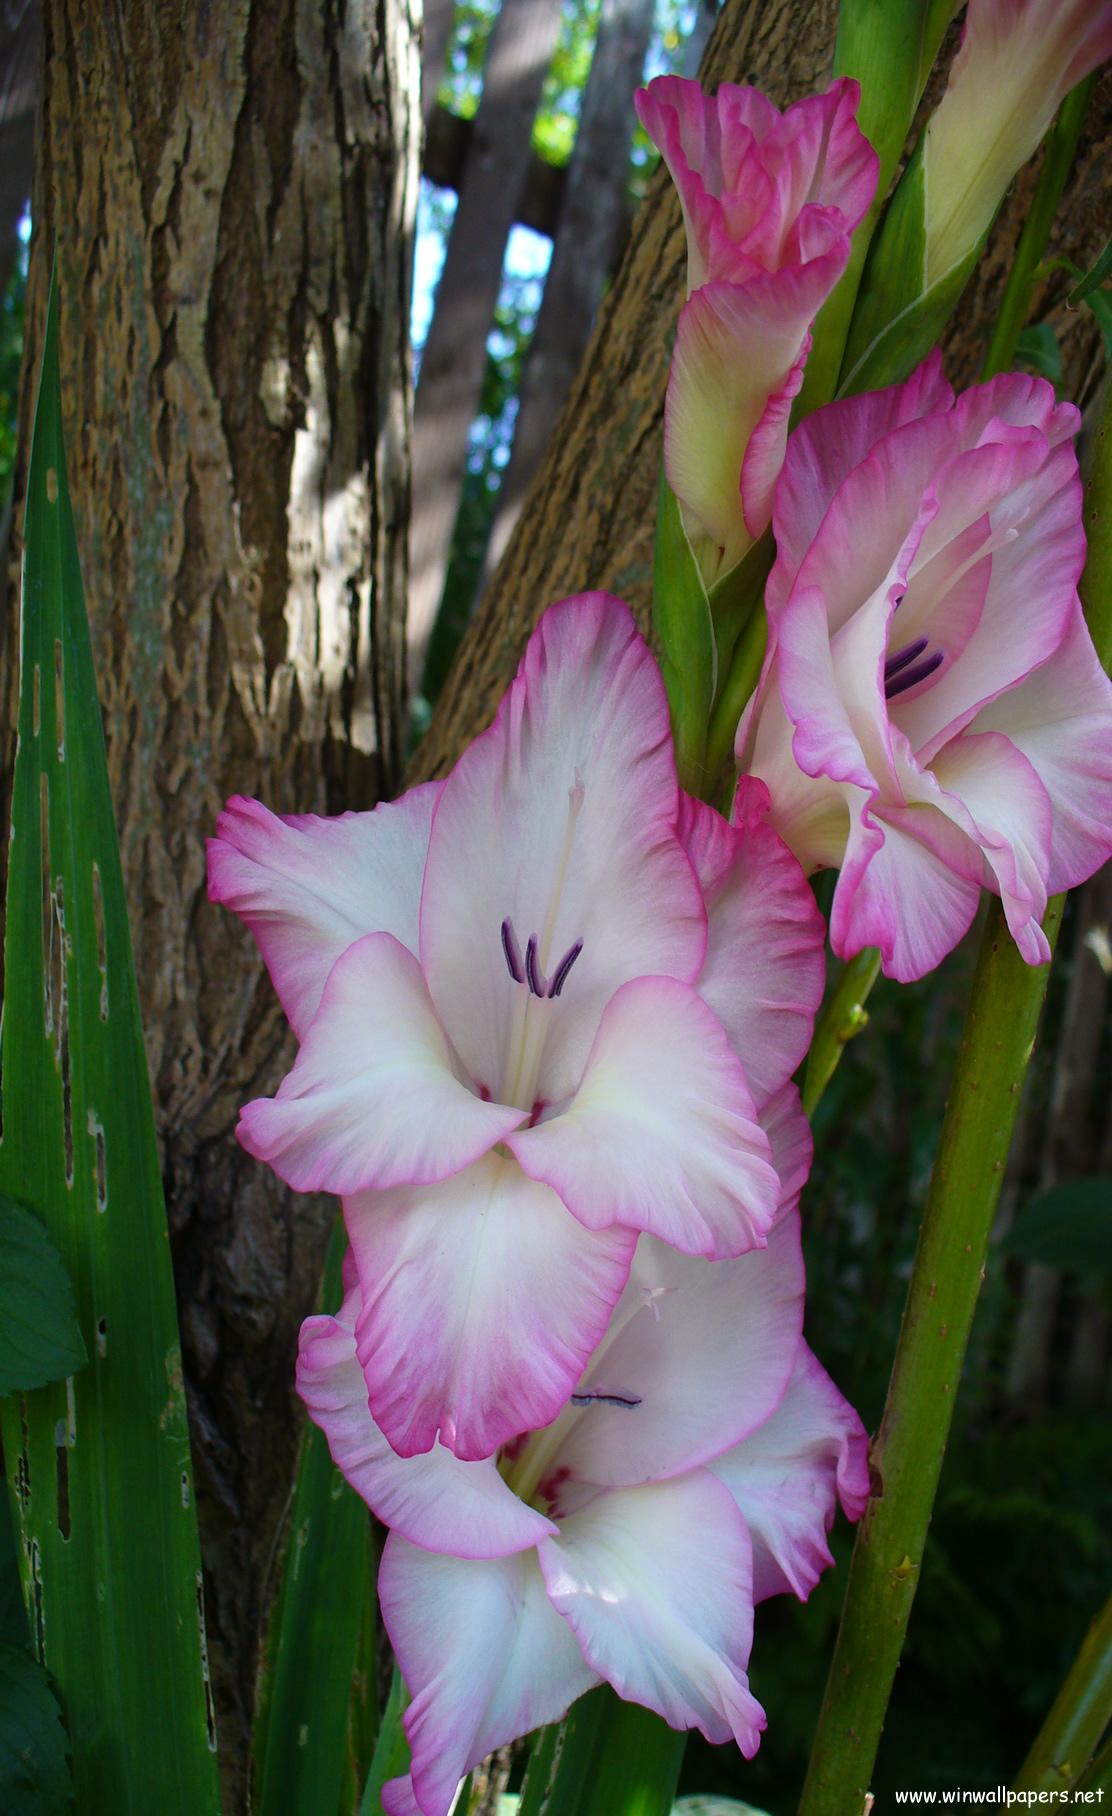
[738,356,1112,981]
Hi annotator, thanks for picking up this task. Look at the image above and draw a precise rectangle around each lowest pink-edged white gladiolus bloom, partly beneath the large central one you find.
[298,1086,869,1816]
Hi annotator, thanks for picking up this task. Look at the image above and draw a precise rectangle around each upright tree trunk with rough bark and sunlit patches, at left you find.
[4,0,420,1809]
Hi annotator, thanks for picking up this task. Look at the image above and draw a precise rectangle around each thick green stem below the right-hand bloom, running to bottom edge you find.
[799,897,1063,1816]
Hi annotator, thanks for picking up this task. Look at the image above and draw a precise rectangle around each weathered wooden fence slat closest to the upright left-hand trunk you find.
[409,0,560,688]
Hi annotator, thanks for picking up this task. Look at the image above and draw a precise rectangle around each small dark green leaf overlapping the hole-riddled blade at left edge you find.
[0,1197,85,1393]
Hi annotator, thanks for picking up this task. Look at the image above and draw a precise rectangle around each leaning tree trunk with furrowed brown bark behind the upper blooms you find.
[412,23,1112,779]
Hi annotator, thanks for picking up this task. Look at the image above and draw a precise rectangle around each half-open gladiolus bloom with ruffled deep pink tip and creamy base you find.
[636,76,879,587]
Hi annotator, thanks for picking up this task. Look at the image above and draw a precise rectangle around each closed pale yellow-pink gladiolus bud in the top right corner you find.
[923,0,1112,289]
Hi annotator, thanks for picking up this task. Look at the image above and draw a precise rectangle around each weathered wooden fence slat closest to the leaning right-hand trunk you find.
[480,0,654,590]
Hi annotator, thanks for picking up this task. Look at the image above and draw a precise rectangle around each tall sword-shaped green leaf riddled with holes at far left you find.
[0,268,218,1816]
